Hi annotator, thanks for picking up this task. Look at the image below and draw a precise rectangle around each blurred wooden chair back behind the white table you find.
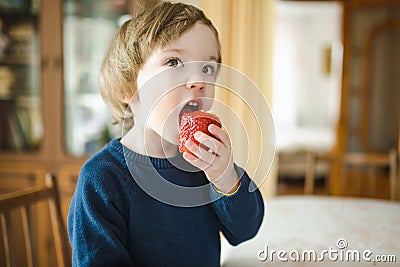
[305,150,400,200]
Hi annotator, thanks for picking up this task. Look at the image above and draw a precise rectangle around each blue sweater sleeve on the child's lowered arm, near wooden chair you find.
[68,164,132,266]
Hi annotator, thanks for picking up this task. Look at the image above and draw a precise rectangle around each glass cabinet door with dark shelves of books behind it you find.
[0,0,43,152]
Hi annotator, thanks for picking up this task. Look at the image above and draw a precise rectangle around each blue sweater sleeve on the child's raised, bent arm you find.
[210,165,264,245]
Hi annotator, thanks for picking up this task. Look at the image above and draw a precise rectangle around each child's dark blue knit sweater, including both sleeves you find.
[68,139,264,267]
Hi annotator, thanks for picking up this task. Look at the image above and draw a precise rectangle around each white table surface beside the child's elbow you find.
[221,196,400,267]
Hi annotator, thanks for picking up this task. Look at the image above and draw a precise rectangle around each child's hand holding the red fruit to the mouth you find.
[183,124,240,194]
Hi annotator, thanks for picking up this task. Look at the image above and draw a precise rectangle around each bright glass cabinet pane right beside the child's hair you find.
[63,0,131,156]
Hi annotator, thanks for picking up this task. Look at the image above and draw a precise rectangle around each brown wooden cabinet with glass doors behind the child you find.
[0,0,140,266]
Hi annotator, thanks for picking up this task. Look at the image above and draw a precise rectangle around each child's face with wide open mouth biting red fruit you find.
[132,23,218,148]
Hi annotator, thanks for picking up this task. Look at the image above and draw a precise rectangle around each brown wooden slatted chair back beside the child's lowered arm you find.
[0,174,71,267]
